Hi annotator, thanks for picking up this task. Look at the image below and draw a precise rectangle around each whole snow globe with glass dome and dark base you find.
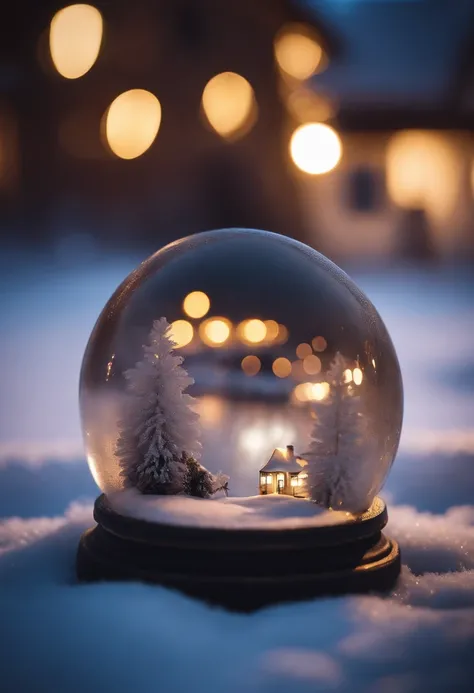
[77,229,403,610]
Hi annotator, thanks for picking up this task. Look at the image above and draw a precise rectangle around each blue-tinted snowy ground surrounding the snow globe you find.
[0,255,474,693]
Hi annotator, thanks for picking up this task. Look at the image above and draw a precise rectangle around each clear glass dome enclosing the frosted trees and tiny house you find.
[80,229,403,512]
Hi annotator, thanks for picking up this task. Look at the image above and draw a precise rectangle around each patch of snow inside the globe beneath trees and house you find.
[108,489,355,529]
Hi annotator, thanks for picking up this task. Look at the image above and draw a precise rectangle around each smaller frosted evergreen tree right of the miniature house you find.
[307,352,369,512]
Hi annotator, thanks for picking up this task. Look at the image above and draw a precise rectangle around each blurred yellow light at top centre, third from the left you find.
[202,72,256,137]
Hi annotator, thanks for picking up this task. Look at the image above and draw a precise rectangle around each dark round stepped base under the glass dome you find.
[77,495,400,611]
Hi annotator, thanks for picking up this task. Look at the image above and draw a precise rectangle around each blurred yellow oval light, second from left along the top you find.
[105,89,161,159]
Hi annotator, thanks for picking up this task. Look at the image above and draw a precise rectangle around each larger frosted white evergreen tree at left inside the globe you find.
[116,318,206,495]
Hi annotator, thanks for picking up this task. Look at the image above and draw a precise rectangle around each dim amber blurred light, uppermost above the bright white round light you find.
[275,25,323,80]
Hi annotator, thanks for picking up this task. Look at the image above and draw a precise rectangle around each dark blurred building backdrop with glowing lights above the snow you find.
[0,0,474,261]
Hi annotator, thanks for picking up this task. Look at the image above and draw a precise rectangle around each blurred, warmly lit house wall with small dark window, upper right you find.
[295,131,474,260]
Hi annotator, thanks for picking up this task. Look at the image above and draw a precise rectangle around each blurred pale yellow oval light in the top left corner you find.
[49,5,103,79]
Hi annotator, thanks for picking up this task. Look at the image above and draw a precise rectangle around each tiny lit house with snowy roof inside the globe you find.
[260,445,308,498]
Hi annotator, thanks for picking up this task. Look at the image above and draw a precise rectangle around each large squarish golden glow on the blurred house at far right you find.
[387,130,461,218]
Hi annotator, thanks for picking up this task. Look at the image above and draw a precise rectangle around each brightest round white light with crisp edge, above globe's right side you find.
[290,123,342,175]
